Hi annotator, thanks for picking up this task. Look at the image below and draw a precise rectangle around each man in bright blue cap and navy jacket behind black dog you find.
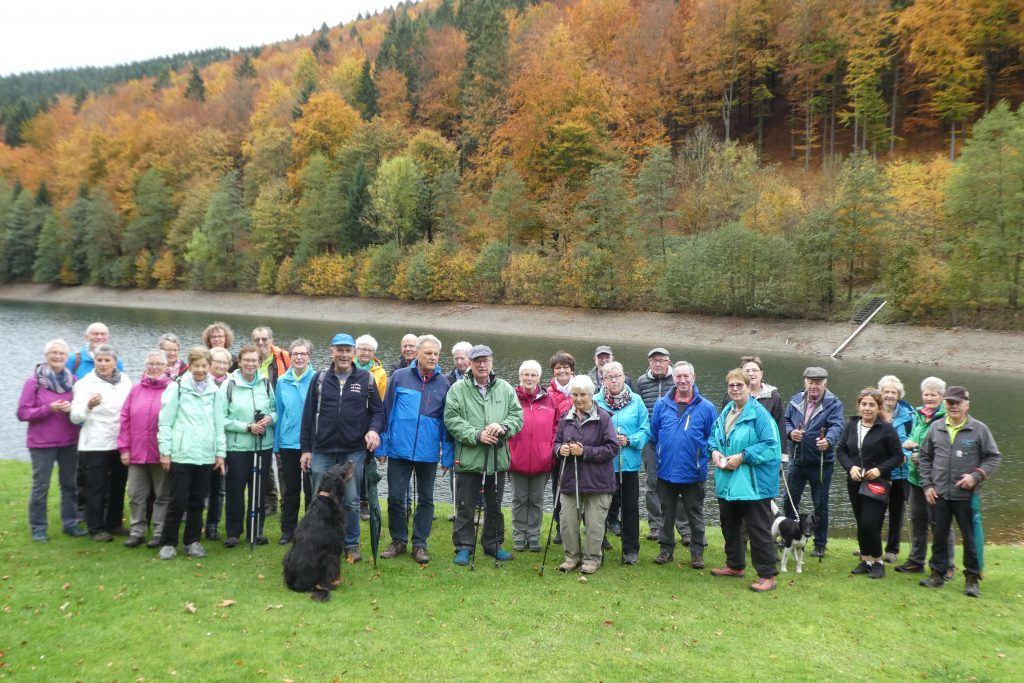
[299,334,384,562]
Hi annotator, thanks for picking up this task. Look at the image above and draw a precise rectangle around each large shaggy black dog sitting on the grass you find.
[283,461,353,602]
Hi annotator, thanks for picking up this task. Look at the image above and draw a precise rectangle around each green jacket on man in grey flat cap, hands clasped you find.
[444,373,522,473]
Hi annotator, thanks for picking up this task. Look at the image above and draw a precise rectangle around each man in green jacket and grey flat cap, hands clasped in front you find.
[444,344,522,565]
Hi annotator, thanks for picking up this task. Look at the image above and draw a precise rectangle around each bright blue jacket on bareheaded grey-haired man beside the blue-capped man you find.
[377,362,455,467]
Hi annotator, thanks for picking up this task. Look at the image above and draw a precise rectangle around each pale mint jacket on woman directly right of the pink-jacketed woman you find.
[157,373,225,465]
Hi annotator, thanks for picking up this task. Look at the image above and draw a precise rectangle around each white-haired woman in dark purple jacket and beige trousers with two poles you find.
[554,375,618,573]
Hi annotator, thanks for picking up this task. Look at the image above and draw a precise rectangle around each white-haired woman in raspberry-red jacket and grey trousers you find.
[509,360,558,553]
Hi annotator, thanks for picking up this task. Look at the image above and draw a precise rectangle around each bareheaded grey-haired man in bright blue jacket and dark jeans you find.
[377,335,454,564]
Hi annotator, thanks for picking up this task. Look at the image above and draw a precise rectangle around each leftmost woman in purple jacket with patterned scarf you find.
[17,339,85,543]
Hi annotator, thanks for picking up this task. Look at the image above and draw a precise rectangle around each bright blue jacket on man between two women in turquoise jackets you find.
[650,385,718,483]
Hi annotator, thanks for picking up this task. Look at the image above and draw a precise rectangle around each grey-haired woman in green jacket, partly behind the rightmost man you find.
[896,377,953,581]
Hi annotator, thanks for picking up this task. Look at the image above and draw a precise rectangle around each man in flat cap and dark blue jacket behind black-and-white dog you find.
[785,367,843,557]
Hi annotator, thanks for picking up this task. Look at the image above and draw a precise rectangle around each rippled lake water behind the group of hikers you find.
[0,301,1024,542]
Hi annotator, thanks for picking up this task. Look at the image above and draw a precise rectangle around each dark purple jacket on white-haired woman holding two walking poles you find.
[554,403,618,496]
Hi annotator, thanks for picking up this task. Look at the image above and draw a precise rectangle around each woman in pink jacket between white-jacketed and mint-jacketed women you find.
[118,350,171,548]
